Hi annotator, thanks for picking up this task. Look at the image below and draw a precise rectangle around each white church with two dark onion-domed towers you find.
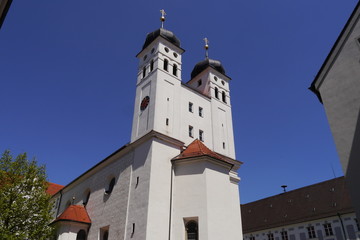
[52,13,243,240]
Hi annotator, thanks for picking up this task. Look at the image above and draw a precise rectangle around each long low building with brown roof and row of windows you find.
[241,177,360,240]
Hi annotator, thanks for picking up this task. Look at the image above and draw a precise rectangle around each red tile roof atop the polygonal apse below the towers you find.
[175,139,224,161]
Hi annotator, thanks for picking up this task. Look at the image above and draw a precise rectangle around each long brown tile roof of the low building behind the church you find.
[241,177,354,233]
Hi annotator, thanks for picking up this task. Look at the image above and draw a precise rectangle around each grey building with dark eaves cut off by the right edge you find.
[310,3,360,217]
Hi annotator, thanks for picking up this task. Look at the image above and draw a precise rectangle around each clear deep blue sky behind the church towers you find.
[0,0,357,203]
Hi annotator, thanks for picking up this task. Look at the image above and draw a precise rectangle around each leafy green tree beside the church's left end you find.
[0,150,52,240]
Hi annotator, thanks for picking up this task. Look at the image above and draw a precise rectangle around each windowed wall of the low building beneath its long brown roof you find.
[244,213,360,240]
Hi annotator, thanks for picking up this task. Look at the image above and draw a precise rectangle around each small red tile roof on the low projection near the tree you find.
[53,205,91,224]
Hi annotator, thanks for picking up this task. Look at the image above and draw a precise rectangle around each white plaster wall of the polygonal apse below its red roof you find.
[172,160,242,240]
